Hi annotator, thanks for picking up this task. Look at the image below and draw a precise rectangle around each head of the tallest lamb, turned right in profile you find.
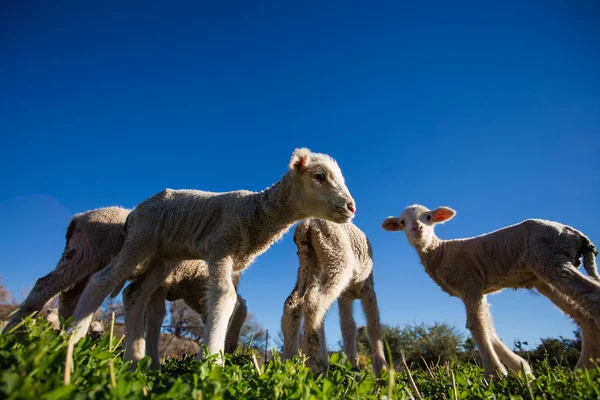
[289,149,356,223]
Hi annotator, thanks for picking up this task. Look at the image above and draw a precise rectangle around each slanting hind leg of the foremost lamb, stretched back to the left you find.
[69,240,153,343]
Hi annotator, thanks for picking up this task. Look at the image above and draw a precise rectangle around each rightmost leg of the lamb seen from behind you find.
[360,275,388,376]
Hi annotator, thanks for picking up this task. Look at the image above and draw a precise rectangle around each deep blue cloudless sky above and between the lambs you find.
[0,1,600,347]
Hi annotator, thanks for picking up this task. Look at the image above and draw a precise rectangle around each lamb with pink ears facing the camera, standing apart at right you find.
[382,205,600,376]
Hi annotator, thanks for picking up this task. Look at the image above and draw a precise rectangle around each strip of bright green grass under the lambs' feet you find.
[0,320,600,400]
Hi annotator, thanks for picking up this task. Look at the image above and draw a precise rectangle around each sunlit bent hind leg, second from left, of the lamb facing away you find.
[302,270,352,373]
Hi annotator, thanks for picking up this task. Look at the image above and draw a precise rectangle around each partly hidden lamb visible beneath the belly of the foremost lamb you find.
[123,260,247,370]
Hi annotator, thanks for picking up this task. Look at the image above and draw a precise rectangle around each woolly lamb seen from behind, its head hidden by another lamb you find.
[281,218,387,375]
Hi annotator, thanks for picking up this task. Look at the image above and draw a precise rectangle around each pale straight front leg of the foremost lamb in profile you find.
[203,257,237,364]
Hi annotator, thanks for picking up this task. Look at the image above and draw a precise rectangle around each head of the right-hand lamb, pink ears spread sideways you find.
[381,204,456,250]
